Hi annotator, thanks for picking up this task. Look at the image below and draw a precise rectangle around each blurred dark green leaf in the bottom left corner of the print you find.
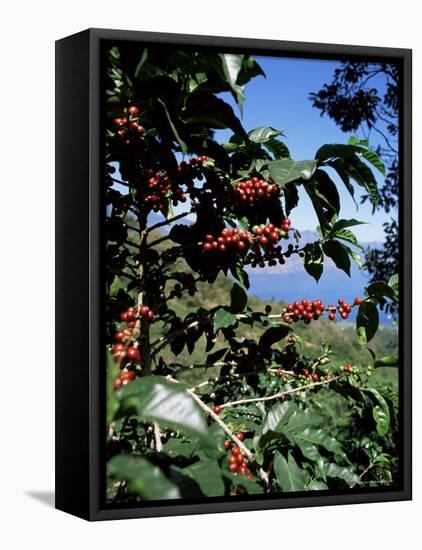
[107,455,181,500]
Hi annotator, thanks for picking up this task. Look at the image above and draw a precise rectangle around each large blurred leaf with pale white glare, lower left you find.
[118,375,208,439]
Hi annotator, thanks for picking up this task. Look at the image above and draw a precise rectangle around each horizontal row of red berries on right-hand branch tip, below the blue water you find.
[283,298,362,324]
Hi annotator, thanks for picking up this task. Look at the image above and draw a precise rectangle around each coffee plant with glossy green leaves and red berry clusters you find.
[103,43,399,505]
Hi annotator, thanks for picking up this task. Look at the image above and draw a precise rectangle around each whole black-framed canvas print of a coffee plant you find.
[56,29,411,520]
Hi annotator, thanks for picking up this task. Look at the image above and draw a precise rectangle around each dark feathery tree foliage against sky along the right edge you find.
[310,62,400,312]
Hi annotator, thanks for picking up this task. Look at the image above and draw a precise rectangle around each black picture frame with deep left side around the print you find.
[56,29,412,520]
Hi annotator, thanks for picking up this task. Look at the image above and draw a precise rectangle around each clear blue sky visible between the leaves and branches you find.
[216,57,396,242]
